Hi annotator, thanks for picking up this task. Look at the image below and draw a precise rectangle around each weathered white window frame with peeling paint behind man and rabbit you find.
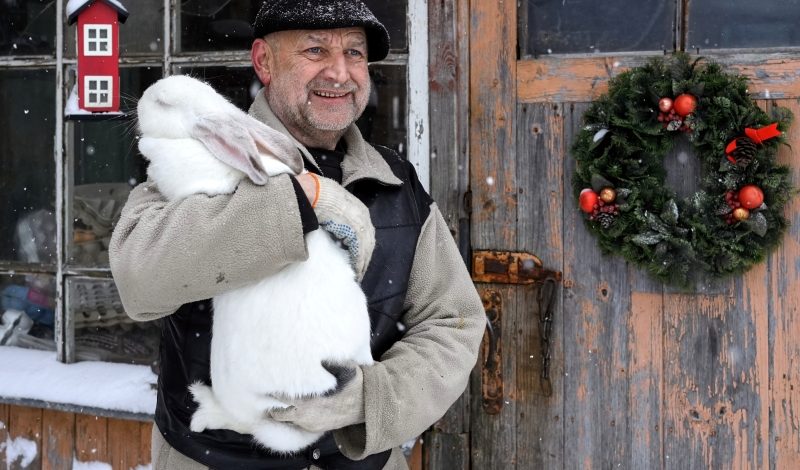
[0,0,430,382]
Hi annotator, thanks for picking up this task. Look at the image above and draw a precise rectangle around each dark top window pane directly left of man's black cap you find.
[178,0,261,52]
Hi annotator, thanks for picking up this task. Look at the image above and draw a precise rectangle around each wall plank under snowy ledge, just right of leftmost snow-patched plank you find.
[42,410,75,470]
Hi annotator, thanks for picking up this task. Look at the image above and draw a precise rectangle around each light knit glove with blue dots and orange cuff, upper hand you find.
[314,176,375,281]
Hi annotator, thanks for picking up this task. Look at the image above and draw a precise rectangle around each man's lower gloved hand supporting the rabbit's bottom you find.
[269,365,365,432]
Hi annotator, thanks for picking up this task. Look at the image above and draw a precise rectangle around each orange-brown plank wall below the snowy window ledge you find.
[0,404,152,470]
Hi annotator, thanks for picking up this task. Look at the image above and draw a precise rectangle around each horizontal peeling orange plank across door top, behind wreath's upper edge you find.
[517,54,800,103]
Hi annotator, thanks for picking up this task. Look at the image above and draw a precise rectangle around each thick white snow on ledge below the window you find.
[0,346,158,415]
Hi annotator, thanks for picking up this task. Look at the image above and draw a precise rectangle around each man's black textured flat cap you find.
[253,0,389,62]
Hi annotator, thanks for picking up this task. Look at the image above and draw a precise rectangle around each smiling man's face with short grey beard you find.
[254,28,370,147]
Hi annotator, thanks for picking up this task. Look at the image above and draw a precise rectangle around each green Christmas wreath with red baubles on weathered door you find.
[572,54,794,286]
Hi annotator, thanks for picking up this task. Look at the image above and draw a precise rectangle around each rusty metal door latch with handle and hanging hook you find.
[472,251,561,414]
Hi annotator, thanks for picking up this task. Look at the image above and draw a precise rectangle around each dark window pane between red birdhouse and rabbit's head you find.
[67,67,161,267]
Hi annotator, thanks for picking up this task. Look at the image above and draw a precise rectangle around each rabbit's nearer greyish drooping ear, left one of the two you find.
[191,114,268,185]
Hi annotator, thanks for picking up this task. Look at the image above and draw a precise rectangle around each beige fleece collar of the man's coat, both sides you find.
[250,88,403,186]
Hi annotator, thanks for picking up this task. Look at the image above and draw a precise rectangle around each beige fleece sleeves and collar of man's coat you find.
[110,91,486,468]
